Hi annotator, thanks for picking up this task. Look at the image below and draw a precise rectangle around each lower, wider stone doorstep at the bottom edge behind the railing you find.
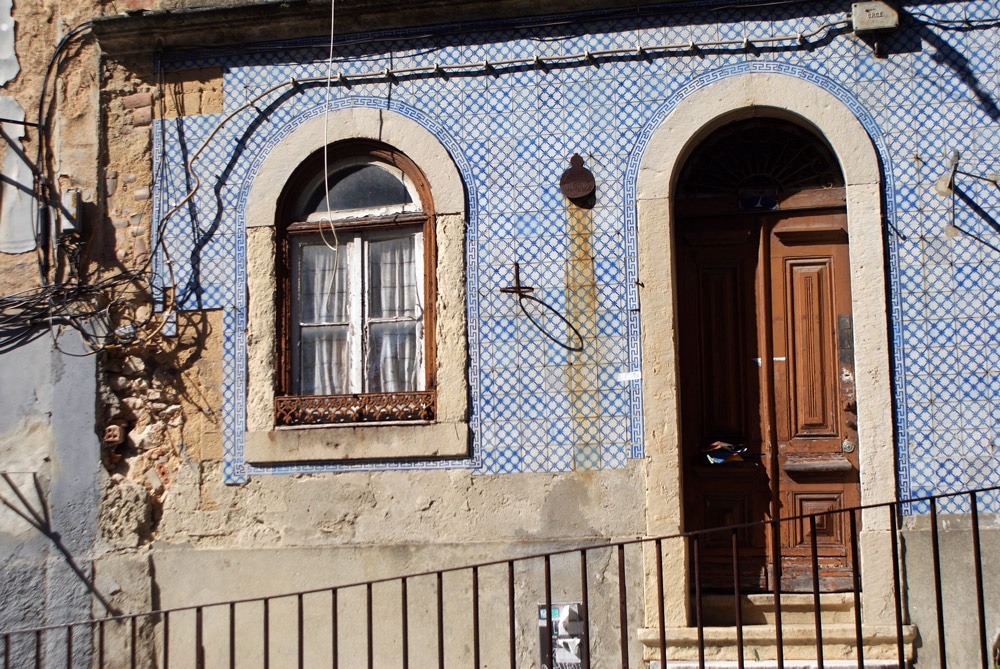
[639,624,916,669]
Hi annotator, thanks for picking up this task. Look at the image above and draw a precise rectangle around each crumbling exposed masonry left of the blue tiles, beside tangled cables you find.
[93,53,222,532]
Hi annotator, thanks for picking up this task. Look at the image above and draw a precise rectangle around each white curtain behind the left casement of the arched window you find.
[293,236,350,395]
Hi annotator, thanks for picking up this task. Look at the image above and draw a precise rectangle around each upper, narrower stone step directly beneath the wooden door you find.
[702,592,854,627]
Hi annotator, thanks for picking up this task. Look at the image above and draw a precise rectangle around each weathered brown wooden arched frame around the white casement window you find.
[274,140,437,427]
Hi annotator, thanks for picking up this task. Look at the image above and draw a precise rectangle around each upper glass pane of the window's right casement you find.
[368,233,418,318]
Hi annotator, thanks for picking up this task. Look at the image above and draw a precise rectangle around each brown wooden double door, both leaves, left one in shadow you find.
[676,210,858,591]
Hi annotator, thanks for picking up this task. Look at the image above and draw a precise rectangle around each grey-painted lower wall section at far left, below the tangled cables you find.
[0,337,101,664]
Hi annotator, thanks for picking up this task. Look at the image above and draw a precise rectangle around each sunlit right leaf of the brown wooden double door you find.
[769,213,859,591]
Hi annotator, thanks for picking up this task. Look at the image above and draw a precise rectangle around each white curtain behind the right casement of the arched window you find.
[365,236,421,393]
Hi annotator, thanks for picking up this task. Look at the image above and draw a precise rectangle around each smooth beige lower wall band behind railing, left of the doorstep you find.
[143,541,642,667]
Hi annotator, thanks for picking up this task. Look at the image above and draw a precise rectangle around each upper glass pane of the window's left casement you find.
[293,235,348,324]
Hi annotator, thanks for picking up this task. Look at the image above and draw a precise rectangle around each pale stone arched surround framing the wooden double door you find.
[636,72,896,627]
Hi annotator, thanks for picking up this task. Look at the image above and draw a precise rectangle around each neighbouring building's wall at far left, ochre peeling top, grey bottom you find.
[0,2,108,666]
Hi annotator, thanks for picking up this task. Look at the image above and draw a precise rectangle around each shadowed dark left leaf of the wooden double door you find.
[677,218,771,590]
